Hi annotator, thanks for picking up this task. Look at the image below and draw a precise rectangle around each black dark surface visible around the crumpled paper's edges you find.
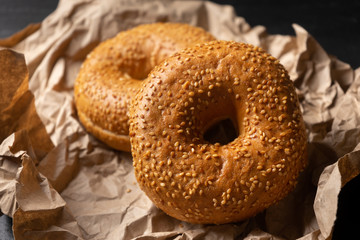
[0,0,360,240]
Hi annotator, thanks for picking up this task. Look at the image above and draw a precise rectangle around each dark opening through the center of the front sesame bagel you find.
[203,118,239,145]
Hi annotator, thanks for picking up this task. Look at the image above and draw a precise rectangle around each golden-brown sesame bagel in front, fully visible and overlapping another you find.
[130,41,307,224]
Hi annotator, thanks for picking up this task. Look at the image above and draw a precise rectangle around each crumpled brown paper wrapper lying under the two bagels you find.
[0,0,360,239]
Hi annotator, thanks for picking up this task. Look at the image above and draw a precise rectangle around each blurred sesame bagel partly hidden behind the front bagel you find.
[74,23,214,151]
